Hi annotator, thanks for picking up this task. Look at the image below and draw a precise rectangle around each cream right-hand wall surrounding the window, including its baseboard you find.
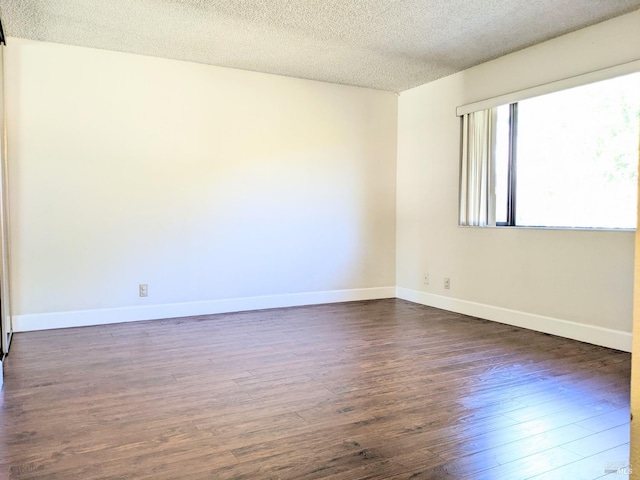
[396,11,640,349]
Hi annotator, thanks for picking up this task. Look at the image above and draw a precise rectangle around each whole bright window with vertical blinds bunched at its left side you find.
[460,73,640,229]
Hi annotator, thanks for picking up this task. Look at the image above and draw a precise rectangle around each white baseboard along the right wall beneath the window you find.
[396,287,632,352]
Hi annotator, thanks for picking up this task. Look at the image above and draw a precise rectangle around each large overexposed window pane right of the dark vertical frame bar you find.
[516,74,640,228]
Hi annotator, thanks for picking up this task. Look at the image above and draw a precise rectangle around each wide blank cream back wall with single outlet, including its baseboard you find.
[6,38,397,330]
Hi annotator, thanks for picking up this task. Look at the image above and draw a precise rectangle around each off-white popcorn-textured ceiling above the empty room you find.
[0,0,640,92]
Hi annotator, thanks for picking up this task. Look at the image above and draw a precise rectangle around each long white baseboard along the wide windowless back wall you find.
[13,287,396,332]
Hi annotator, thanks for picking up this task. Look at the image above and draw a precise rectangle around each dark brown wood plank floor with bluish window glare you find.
[0,300,630,480]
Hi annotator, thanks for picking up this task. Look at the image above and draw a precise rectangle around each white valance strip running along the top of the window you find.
[456,60,640,117]
